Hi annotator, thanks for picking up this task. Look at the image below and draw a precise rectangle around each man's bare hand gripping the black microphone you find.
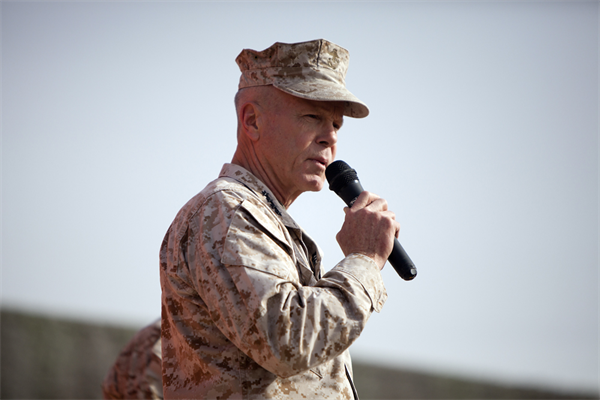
[336,191,400,270]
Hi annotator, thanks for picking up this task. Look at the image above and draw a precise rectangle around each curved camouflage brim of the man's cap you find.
[273,80,369,118]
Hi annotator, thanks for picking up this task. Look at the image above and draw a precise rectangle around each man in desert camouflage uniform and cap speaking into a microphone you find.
[160,40,399,400]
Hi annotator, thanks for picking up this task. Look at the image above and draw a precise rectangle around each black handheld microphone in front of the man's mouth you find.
[325,160,417,281]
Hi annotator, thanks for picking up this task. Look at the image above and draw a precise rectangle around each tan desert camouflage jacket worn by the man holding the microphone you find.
[160,164,387,400]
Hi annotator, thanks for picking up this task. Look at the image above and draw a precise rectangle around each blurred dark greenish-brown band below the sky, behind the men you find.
[0,309,597,400]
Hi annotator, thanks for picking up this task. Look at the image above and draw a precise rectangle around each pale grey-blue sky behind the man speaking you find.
[0,0,600,393]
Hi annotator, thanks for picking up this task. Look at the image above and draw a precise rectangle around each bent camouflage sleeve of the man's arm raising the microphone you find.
[188,193,386,377]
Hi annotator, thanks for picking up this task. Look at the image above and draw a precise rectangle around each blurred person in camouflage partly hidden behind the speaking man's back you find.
[102,319,163,400]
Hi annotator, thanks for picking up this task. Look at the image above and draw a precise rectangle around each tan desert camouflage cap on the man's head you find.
[235,39,369,118]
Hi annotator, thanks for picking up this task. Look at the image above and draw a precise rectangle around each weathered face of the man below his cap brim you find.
[260,89,343,206]
